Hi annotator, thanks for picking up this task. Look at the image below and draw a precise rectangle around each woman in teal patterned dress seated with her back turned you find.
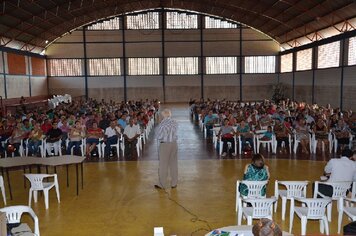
[239,154,270,196]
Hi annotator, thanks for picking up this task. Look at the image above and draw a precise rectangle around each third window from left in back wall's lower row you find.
[128,58,160,75]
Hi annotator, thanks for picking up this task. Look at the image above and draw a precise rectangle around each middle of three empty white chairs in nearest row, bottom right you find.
[289,198,331,235]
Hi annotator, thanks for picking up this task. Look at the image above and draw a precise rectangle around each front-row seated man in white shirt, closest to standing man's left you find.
[124,117,141,156]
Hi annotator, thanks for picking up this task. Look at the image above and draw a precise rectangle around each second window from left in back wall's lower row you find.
[88,58,121,76]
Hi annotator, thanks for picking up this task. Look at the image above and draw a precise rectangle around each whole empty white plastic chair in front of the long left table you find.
[25,174,60,209]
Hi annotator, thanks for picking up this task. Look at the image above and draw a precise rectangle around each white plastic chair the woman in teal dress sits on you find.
[235,180,268,211]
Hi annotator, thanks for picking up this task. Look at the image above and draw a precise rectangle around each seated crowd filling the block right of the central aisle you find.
[190,99,356,155]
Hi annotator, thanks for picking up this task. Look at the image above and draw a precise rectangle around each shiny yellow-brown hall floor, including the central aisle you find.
[0,105,347,236]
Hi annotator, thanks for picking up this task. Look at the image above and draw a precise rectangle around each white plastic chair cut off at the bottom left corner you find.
[0,206,40,236]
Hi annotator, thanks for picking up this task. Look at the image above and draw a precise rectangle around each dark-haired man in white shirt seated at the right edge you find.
[313,149,356,197]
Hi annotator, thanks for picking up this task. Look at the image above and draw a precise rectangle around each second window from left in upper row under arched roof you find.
[126,12,159,29]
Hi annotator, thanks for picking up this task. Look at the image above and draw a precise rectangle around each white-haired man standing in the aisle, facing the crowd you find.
[155,109,178,189]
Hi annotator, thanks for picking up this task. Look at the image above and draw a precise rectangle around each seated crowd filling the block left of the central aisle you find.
[0,99,159,157]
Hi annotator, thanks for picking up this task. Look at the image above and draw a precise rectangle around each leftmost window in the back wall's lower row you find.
[48,59,83,76]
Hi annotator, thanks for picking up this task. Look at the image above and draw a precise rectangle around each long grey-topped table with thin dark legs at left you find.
[0,155,85,199]
